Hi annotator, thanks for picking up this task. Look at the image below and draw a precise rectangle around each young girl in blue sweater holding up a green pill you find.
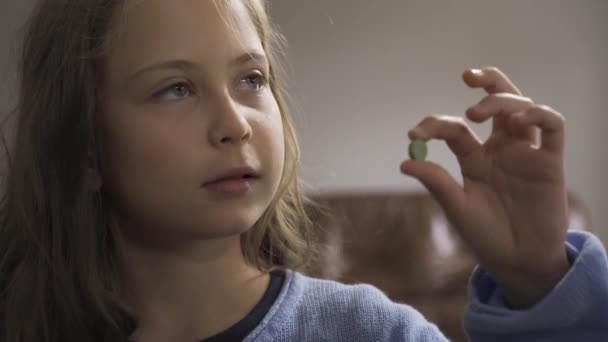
[0,0,608,342]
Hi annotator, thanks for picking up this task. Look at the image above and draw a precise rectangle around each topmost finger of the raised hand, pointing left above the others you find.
[462,67,521,95]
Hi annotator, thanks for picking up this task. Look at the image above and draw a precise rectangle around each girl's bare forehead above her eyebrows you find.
[109,0,263,72]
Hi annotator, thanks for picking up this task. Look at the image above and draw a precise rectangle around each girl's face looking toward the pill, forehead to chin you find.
[101,0,284,244]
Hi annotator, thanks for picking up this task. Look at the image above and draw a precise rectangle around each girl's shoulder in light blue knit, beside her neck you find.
[243,270,445,341]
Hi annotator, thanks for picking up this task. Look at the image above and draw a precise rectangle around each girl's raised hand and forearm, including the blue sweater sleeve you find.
[401,67,608,341]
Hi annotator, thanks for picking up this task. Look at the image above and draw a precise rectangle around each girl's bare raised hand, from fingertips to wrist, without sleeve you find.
[401,67,569,308]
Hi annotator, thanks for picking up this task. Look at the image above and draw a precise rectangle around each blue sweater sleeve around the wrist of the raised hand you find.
[464,231,608,342]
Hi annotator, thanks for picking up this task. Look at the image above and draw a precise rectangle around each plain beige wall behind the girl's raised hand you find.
[271,0,608,239]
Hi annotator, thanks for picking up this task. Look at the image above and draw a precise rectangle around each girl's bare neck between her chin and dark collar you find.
[119,231,269,342]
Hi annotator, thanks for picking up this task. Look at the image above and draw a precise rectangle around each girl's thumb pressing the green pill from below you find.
[401,160,466,218]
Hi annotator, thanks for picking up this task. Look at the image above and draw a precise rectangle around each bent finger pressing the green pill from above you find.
[408,115,482,159]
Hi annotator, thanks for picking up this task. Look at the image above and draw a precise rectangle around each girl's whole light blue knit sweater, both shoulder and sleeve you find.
[245,232,608,342]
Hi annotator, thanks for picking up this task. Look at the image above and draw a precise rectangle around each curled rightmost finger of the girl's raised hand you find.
[511,105,565,153]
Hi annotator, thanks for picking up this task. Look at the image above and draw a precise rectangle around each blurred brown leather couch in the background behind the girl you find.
[312,193,591,341]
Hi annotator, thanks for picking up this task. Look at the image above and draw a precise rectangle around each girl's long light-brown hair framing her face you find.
[0,0,317,342]
